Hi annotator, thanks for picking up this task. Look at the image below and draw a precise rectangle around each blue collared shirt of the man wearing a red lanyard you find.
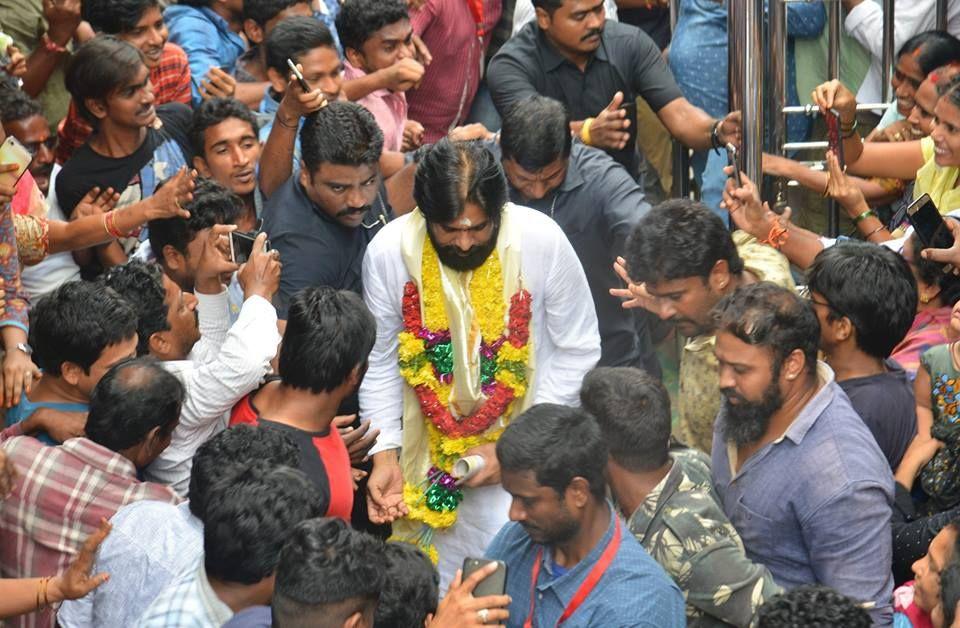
[486,506,687,628]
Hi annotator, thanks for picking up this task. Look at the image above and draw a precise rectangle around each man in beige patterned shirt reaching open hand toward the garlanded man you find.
[610,199,794,453]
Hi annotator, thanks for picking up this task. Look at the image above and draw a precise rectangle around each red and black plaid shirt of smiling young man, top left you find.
[57,42,190,164]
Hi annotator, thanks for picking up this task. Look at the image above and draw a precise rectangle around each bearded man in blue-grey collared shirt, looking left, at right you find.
[712,282,893,625]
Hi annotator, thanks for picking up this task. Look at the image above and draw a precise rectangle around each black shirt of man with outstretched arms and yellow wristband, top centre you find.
[487,20,683,176]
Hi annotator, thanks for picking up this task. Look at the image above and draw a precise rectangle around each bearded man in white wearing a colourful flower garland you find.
[360,140,600,588]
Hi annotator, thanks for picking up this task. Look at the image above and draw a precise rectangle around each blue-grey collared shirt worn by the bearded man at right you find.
[713,362,893,626]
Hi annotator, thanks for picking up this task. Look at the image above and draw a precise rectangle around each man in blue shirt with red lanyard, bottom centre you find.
[488,403,687,628]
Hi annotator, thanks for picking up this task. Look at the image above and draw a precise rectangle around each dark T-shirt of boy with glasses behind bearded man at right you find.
[837,360,917,469]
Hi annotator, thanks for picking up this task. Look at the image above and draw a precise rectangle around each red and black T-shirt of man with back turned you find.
[230,392,353,523]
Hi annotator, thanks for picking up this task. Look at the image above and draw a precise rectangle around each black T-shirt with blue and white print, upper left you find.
[55,103,193,216]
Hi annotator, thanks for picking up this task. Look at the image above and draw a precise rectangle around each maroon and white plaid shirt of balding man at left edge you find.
[0,426,179,628]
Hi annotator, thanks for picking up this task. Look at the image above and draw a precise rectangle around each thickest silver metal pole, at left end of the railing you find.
[727,0,764,189]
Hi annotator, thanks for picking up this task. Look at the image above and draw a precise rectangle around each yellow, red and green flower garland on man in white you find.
[398,240,531,556]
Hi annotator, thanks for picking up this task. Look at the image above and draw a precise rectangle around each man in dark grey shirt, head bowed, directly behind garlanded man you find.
[489,95,660,377]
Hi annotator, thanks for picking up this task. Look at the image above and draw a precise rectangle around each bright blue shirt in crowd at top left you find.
[163,4,247,106]
